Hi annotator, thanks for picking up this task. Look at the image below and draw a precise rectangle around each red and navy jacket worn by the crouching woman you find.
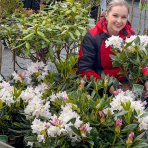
[78,17,135,81]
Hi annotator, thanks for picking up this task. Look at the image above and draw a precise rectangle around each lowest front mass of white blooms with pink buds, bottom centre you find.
[28,103,92,143]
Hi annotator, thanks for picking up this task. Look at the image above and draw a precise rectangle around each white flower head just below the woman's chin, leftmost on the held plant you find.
[105,36,123,50]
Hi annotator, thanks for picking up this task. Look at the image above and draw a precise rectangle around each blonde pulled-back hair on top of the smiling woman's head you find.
[106,0,129,13]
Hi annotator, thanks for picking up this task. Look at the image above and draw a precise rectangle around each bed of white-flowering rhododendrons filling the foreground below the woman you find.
[0,62,148,148]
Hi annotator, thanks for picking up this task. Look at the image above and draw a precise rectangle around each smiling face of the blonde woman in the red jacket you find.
[106,6,128,35]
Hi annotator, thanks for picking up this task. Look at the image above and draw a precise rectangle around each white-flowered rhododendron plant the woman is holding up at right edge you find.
[105,35,148,84]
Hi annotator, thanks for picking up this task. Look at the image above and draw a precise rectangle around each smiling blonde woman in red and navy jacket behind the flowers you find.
[78,0,134,94]
